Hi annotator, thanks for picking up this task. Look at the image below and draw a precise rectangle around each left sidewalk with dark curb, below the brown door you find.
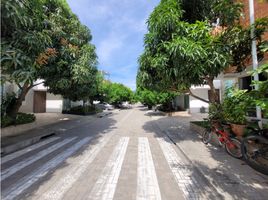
[1,111,111,155]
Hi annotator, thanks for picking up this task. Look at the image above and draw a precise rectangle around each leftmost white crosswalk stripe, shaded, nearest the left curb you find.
[1,137,59,164]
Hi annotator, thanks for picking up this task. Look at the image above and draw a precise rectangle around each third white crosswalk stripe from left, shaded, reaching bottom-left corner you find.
[2,137,91,200]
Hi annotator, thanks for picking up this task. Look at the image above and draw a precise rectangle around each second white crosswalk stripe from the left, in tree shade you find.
[1,137,76,181]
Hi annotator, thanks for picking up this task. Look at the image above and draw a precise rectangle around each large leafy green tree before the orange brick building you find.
[137,0,265,102]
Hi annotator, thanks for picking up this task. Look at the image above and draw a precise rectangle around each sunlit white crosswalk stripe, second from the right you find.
[136,137,161,200]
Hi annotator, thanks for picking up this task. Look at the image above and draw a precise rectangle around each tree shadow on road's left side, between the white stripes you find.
[1,113,117,199]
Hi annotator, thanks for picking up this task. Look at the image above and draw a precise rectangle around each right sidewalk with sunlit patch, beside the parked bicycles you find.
[152,113,268,200]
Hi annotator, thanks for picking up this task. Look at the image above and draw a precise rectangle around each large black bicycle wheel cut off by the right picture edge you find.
[242,135,268,175]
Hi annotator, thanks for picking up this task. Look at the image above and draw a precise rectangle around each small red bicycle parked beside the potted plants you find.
[202,119,242,158]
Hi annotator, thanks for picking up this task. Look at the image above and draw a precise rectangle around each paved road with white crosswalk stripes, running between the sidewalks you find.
[1,107,220,200]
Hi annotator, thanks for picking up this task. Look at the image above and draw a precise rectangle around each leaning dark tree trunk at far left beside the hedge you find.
[7,83,32,120]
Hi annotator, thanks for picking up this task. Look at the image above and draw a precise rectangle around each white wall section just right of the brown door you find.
[46,92,63,113]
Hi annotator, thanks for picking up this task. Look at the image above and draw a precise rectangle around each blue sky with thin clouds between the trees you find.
[67,0,160,90]
